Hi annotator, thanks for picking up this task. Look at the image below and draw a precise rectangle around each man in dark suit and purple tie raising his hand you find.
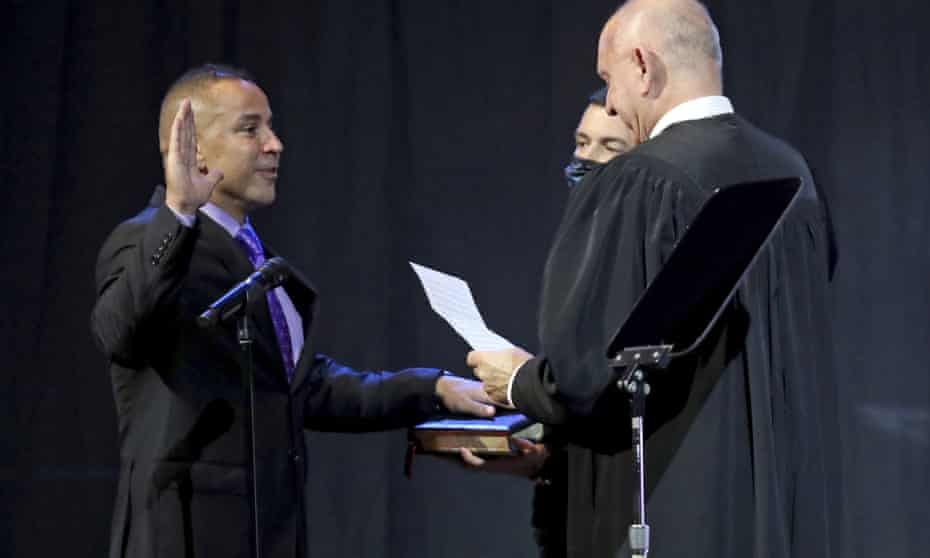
[91,66,493,558]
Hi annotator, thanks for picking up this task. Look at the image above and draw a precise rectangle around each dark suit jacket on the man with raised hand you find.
[91,189,439,558]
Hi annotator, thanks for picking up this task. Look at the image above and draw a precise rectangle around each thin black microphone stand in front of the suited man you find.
[236,289,262,558]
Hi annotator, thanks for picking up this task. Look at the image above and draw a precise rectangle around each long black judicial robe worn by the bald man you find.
[513,114,838,558]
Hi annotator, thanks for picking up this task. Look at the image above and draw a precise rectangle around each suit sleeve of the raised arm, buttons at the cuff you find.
[90,205,195,363]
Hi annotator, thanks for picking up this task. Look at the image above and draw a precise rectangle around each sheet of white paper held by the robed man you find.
[410,262,513,351]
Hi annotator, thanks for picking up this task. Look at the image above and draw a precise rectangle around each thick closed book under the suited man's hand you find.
[410,413,542,455]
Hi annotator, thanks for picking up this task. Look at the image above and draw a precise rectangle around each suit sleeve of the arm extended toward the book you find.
[304,355,444,432]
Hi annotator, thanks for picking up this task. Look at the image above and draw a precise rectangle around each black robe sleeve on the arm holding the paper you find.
[513,155,708,424]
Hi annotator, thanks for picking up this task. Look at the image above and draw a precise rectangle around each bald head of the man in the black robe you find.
[597,0,723,141]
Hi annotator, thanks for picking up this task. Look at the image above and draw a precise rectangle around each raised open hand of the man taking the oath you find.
[165,99,223,215]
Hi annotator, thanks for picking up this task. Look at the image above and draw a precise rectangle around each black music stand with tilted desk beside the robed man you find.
[607,178,801,558]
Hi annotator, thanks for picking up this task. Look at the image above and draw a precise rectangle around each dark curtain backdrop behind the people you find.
[0,0,930,558]
